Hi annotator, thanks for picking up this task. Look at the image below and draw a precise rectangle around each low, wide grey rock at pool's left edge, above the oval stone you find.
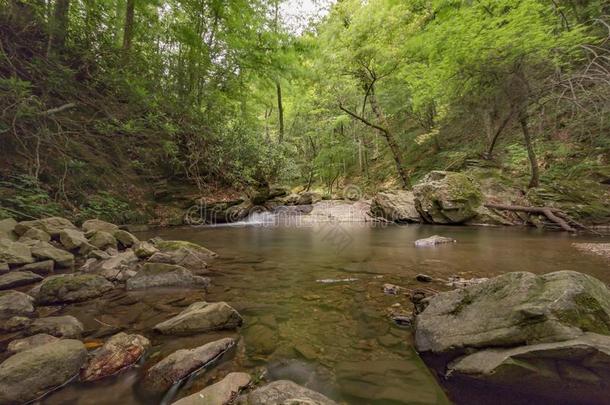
[127,263,210,290]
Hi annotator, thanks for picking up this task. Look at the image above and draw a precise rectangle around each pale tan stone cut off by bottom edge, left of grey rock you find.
[173,373,252,405]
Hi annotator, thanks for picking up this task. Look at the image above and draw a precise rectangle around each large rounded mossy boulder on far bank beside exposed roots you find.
[413,171,483,224]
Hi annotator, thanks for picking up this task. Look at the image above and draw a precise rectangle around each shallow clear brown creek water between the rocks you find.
[32,224,610,404]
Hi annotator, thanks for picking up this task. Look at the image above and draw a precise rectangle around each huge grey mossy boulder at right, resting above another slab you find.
[415,271,610,353]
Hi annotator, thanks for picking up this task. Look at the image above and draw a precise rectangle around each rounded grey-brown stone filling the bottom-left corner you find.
[0,339,87,404]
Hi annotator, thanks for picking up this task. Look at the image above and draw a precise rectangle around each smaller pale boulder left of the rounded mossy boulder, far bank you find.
[371,190,421,222]
